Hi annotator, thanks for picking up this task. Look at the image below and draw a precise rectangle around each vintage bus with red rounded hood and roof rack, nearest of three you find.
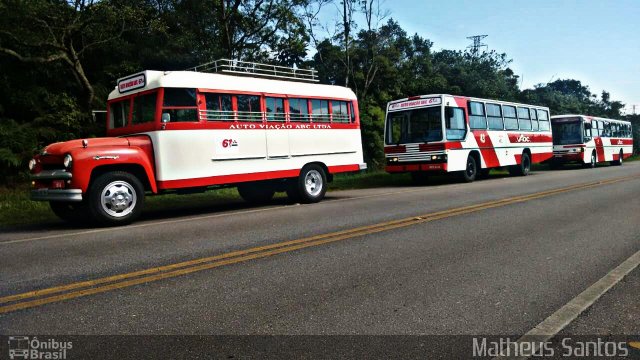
[29,60,366,224]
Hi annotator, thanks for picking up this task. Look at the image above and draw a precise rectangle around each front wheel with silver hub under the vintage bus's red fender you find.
[87,171,144,226]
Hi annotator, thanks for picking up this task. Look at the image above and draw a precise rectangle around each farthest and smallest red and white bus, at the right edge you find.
[551,115,633,168]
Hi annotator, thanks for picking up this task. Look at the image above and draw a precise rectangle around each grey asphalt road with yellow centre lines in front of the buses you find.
[0,163,640,358]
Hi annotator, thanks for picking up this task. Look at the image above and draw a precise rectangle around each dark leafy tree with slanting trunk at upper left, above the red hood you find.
[0,0,142,110]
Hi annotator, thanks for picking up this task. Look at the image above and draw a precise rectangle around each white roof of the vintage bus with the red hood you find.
[108,70,356,100]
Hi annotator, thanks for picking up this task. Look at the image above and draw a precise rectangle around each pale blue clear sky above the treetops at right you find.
[318,0,640,113]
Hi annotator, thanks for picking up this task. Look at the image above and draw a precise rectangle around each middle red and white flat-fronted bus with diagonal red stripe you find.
[384,95,553,182]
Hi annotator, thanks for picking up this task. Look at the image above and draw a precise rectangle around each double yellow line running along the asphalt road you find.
[0,176,636,314]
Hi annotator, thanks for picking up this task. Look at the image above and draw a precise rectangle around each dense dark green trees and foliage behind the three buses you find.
[0,0,640,183]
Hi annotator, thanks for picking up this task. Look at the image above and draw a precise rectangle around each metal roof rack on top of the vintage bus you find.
[187,59,319,82]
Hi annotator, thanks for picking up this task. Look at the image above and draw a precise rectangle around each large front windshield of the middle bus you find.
[386,106,442,145]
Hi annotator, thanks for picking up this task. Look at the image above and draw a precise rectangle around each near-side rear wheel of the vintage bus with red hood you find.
[287,164,327,204]
